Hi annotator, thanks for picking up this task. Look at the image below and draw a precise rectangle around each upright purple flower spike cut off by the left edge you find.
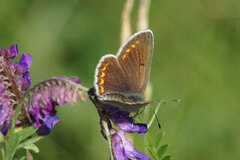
[0,45,32,135]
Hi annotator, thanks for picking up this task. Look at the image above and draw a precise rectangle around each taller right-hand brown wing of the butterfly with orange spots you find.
[117,31,153,95]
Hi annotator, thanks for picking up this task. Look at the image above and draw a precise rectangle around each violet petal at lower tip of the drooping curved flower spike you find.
[37,115,60,136]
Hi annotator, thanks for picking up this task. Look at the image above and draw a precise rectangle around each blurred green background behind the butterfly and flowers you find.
[0,0,240,160]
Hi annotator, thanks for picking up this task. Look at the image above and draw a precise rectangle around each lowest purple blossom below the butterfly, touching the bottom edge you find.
[112,130,150,160]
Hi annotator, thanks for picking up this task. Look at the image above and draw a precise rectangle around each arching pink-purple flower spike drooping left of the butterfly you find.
[26,77,85,135]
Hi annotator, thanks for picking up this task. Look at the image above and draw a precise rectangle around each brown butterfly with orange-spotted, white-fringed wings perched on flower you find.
[94,30,175,112]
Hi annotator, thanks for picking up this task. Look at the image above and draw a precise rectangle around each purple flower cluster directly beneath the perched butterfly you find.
[93,101,150,160]
